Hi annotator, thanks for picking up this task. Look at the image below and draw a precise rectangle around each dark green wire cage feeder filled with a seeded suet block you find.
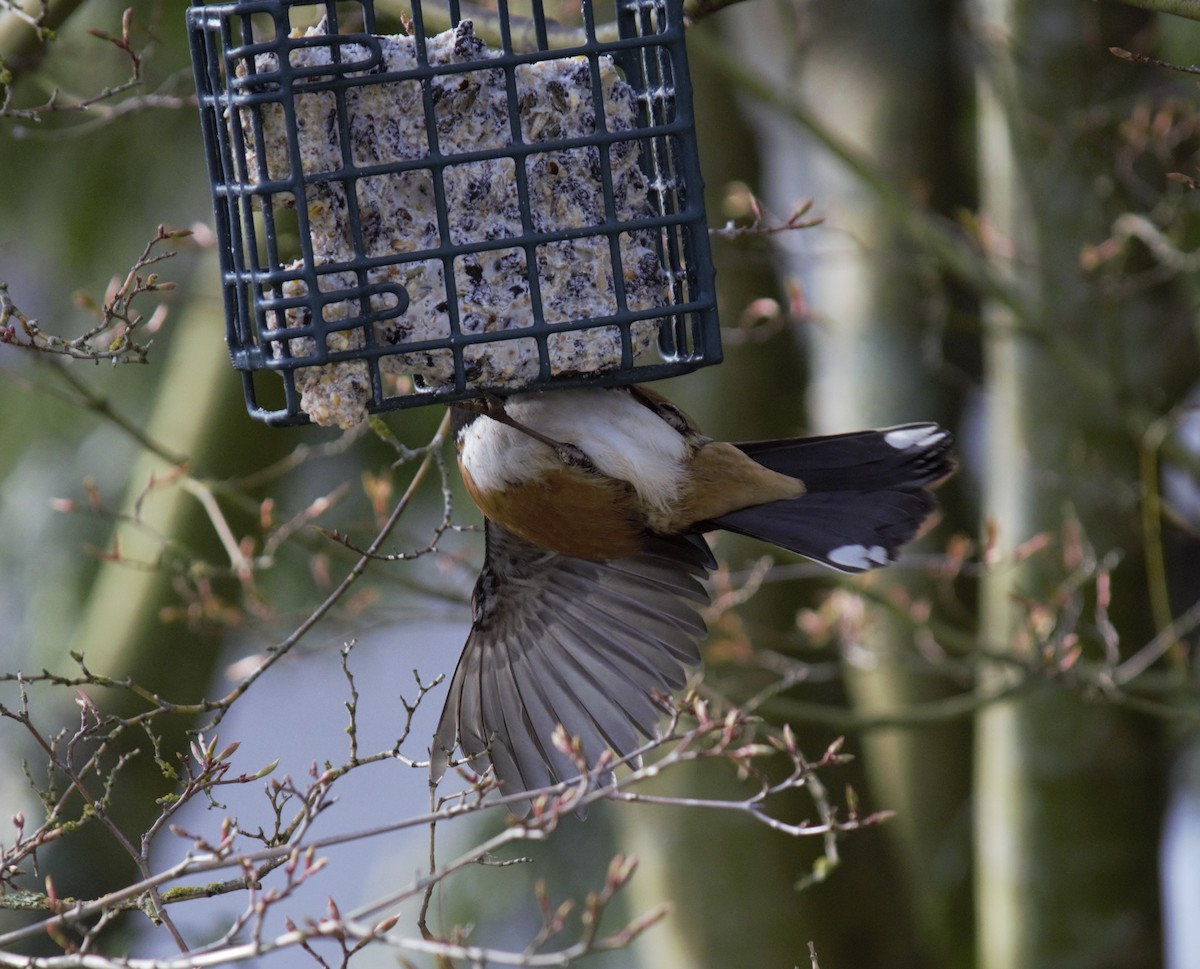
[187,0,721,427]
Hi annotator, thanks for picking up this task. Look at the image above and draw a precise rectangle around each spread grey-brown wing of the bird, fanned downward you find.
[432,522,714,809]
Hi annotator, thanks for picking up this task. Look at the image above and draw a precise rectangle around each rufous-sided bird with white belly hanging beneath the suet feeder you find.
[430,385,954,815]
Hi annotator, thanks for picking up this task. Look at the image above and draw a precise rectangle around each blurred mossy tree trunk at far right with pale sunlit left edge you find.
[972,0,1158,969]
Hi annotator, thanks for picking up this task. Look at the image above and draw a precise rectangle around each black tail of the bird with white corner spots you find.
[703,423,954,572]
